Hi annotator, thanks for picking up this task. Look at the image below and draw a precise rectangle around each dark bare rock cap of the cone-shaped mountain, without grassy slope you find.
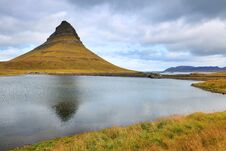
[47,21,81,41]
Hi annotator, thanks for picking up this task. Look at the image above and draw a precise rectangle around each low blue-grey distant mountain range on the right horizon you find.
[163,66,226,72]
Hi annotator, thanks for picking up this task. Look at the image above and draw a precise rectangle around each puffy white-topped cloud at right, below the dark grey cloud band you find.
[144,19,226,55]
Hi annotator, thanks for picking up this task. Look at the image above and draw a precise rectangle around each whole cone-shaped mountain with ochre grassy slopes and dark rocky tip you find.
[0,21,137,74]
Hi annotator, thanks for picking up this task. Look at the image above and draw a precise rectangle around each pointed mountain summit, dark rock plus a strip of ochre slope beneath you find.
[47,20,81,42]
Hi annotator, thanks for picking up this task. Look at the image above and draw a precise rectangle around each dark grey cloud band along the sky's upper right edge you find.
[68,0,226,23]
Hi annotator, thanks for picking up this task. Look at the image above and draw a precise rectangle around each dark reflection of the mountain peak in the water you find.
[49,76,79,122]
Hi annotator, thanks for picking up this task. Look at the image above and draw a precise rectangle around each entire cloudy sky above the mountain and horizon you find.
[0,0,226,71]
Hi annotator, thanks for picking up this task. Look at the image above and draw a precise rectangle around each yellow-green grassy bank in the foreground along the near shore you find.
[11,111,226,151]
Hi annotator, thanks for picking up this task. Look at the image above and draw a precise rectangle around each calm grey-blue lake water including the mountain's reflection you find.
[0,75,226,150]
